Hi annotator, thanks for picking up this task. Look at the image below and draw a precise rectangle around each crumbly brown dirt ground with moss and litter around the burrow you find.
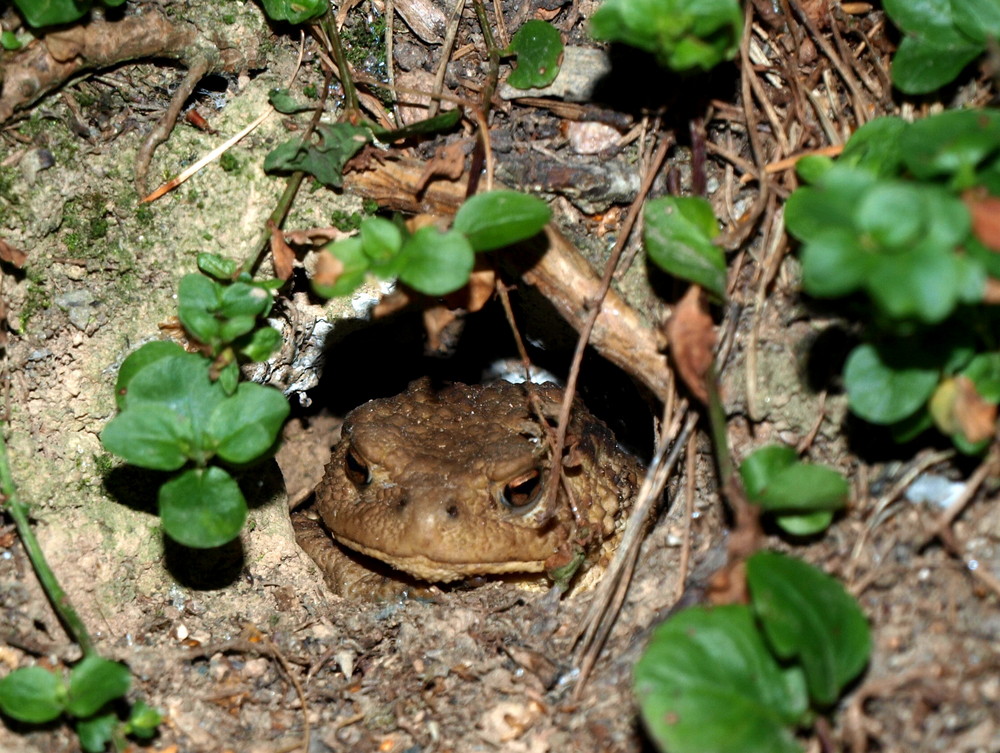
[0,0,1000,753]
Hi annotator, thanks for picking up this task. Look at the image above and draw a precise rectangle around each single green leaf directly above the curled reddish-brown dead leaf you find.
[643,196,726,298]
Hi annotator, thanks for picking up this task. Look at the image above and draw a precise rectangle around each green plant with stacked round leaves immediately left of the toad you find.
[101,254,289,548]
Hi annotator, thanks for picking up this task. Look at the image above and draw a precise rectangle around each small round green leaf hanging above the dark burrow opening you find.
[398,225,475,296]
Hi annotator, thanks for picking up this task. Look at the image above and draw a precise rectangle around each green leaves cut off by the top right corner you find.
[882,0,1000,94]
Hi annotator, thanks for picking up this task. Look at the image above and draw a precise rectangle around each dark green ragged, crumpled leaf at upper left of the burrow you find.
[264,123,371,188]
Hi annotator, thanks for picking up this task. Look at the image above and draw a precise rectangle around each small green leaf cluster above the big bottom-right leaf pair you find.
[740,445,848,536]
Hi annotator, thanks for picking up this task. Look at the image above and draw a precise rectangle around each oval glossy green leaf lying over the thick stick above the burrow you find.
[452,191,552,251]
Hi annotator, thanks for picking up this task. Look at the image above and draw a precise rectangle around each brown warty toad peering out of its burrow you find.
[297,380,640,595]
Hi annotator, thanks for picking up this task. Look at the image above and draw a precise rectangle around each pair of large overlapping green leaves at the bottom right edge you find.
[635,552,871,753]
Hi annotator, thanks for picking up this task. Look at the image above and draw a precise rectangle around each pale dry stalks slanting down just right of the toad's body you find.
[573,412,698,700]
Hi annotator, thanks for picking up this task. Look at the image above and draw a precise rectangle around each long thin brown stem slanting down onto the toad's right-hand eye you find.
[545,136,674,528]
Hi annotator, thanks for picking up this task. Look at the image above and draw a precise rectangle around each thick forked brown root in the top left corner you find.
[0,10,246,194]
